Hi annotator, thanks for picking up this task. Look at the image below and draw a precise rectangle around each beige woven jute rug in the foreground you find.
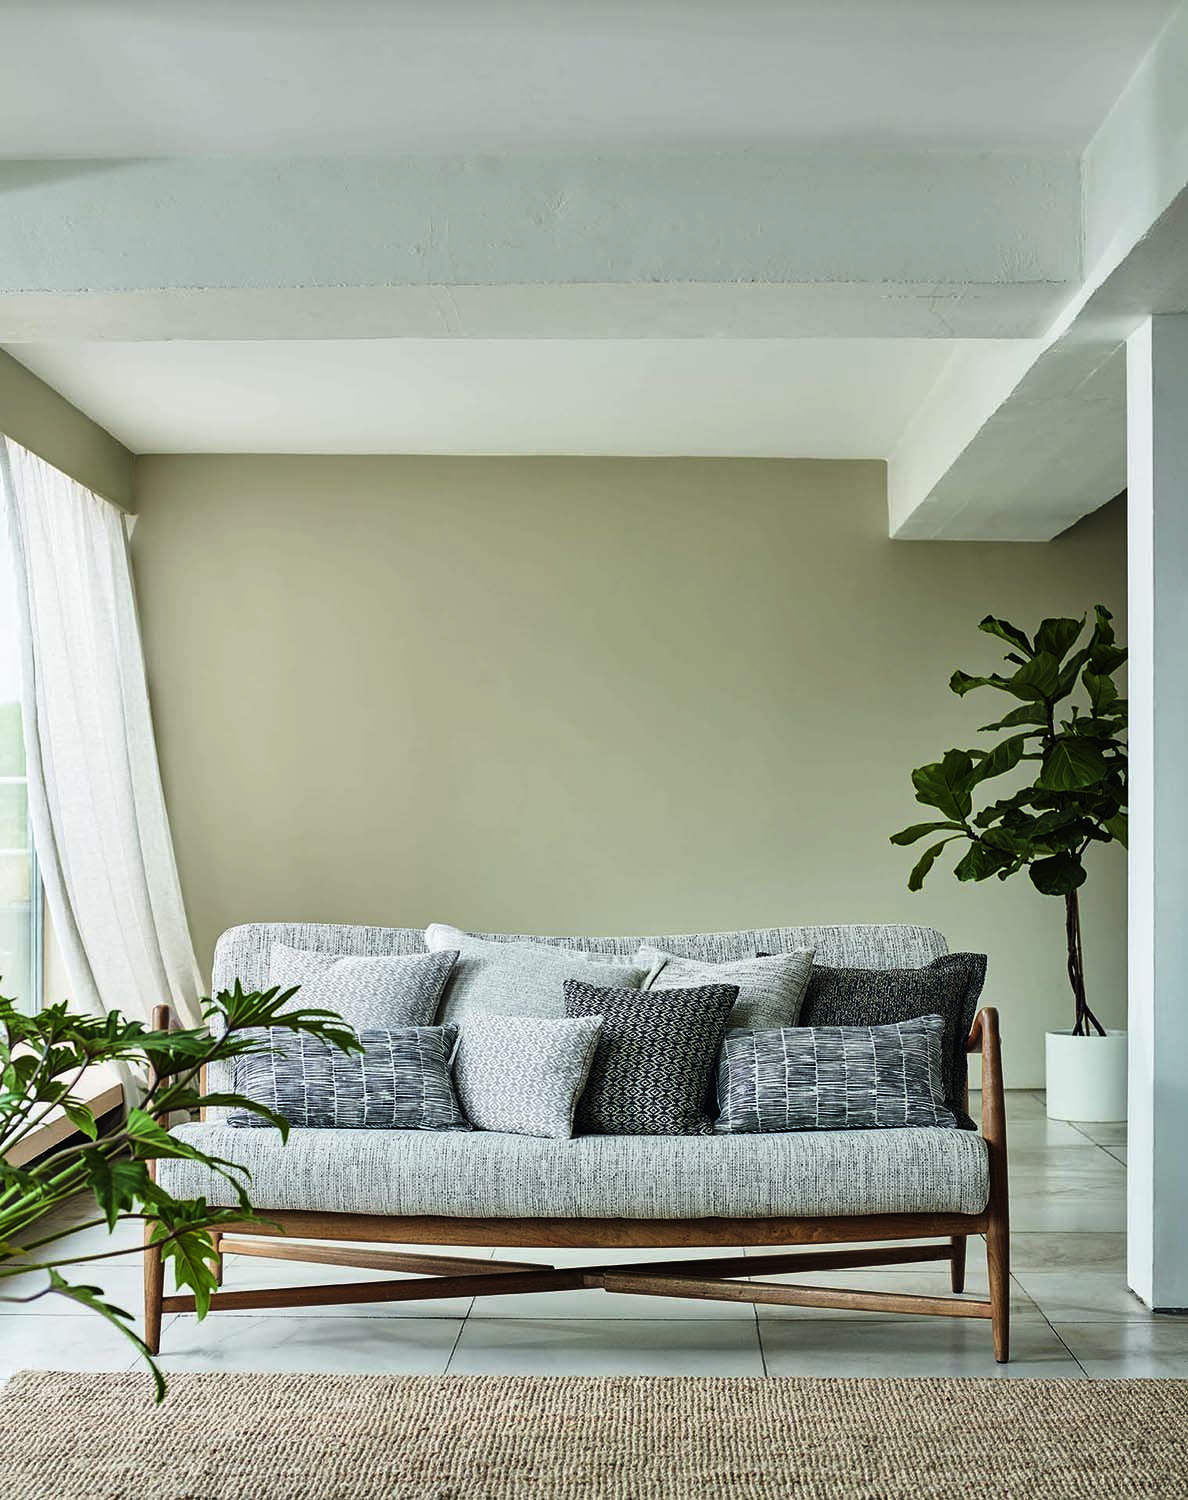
[0,1374,1188,1500]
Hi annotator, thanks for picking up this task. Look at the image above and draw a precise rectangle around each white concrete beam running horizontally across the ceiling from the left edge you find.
[0,152,1080,342]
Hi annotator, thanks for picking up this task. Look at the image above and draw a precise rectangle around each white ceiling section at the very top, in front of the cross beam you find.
[0,0,1173,158]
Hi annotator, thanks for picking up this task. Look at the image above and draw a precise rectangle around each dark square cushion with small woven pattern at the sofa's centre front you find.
[566,980,738,1136]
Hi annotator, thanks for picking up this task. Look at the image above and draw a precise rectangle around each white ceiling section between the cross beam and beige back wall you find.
[9,339,960,459]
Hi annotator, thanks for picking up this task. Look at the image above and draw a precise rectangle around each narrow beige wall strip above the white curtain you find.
[0,350,132,510]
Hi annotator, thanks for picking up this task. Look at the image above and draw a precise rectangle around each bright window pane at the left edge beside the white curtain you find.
[0,528,42,1010]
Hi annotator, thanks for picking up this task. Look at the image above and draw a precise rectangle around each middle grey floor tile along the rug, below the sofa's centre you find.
[449,1317,764,1376]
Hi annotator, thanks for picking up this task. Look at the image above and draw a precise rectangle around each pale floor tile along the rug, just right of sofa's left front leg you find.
[161,1313,462,1376]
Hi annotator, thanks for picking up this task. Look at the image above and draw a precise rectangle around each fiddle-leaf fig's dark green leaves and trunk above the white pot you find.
[891,605,1127,1037]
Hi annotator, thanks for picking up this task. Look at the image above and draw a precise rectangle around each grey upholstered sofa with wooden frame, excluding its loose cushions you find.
[144,923,1010,1362]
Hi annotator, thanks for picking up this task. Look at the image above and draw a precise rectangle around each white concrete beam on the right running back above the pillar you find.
[888,8,1188,542]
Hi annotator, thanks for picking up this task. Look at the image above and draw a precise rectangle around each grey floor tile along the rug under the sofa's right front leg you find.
[759,1316,1083,1380]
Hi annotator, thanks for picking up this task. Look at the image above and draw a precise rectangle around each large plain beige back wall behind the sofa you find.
[134,458,1125,1086]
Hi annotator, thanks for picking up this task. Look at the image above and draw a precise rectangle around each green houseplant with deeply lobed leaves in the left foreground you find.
[0,984,362,1400]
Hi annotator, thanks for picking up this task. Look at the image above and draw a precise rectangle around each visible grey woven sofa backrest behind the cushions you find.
[213,923,948,995]
